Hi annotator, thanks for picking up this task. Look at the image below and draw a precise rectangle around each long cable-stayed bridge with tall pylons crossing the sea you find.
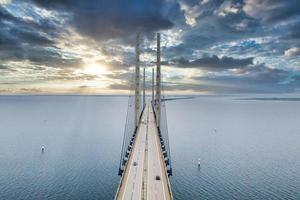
[115,33,173,200]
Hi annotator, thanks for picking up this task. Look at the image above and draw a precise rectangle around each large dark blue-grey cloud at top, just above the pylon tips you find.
[29,0,173,39]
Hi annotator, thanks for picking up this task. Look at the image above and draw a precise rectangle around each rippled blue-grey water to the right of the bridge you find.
[168,97,300,199]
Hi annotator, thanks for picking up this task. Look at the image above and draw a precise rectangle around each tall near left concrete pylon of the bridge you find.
[134,33,140,128]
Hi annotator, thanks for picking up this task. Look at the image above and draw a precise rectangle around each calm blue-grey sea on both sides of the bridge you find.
[0,96,300,200]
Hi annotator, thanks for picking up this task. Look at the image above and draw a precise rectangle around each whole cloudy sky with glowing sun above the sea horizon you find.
[0,0,300,94]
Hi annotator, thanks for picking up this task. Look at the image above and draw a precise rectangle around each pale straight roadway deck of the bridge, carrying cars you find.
[115,104,173,200]
